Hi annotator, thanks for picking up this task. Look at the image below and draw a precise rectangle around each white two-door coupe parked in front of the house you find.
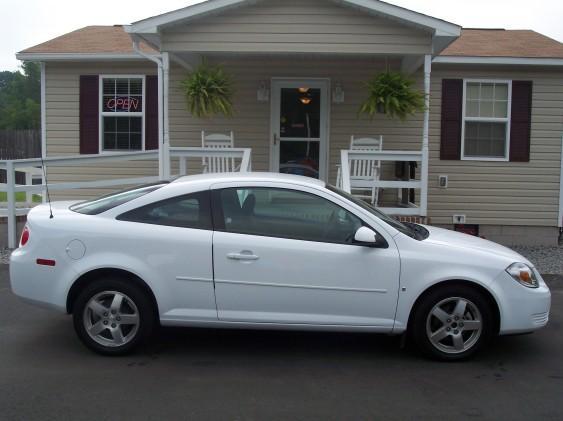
[10,173,551,360]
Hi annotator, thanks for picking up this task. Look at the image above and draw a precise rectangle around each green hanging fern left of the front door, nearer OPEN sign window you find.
[181,62,234,118]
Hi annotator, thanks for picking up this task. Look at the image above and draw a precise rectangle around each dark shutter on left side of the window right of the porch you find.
[440,79,463,160]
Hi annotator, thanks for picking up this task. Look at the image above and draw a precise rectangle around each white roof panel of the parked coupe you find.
[172,172,325,187]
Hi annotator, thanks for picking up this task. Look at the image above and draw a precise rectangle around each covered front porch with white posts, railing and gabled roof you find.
[125,0,460,217]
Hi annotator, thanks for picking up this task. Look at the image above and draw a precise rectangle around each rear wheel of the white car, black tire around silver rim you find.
[73,277,157,356]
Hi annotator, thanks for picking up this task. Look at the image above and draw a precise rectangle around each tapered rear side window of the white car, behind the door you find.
[117,192,213,230]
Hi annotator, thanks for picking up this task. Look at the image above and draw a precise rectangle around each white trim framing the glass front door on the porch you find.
[269,77,331,181]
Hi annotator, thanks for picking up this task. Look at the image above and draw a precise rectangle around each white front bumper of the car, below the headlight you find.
[491,271,551,335]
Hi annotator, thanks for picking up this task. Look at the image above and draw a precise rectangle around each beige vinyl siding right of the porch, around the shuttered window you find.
[428,65,563,227]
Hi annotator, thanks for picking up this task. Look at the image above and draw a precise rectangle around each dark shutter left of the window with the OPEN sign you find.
[80,75,100,154]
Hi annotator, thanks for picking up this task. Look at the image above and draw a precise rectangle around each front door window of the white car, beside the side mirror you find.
[214,187,363,244]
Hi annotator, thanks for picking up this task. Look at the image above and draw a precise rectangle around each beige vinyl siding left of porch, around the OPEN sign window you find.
[45,62,158,200]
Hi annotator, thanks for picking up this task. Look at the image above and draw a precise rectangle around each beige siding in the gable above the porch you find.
[162,0,432,54]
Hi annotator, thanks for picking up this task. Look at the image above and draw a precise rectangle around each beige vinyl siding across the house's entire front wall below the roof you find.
[46,55,563,227]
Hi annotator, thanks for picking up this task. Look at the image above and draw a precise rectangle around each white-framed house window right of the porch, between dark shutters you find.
[462,80,512,161]
